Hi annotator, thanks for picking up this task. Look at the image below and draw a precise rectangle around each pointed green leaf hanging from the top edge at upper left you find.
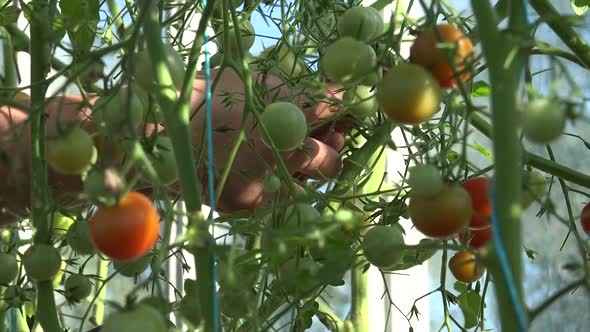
[59,0,100,54]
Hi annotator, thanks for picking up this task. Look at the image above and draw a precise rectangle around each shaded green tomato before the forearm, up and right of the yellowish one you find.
[93,87,145,135]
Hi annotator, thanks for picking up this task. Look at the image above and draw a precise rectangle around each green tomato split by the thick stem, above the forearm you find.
[134,44,186,92]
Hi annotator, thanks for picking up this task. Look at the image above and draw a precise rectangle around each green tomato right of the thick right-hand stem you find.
[522,98,566,144]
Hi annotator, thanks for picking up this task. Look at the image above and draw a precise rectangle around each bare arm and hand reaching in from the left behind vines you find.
[0,69,348,225]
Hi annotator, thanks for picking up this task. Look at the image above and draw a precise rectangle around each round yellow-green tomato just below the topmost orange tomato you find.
[377,64,441,124]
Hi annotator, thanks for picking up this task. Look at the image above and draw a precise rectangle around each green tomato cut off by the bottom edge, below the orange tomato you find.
[100,305,168,332]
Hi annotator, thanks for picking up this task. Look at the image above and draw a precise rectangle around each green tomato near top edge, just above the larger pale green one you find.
[337,7,383,42]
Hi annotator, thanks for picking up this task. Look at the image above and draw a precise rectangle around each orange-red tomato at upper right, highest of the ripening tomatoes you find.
[410,24,473,88]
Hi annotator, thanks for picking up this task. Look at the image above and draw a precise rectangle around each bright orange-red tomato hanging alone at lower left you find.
[89,192,160,261]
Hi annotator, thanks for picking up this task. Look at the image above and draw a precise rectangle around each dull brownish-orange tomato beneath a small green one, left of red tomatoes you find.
[409,185,472,238]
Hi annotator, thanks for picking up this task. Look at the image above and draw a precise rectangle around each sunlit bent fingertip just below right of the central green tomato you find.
[287,138,342,179]
